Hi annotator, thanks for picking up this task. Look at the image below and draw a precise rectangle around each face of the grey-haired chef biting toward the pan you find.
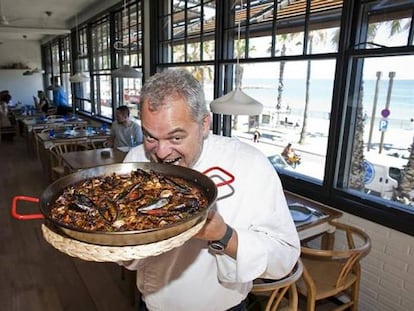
[141,97,210,167]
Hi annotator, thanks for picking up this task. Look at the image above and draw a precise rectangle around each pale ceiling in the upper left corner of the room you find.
[0,0,119,43]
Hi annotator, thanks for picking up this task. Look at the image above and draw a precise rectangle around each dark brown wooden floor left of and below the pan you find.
[0,137,137,311]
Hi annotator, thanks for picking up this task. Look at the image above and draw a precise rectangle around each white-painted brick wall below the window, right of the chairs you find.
[339,214,414,311]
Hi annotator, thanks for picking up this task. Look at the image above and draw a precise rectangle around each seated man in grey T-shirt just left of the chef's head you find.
[106,106,143,148]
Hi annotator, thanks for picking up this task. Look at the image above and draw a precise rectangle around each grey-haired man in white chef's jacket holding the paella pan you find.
[124,70,300,311]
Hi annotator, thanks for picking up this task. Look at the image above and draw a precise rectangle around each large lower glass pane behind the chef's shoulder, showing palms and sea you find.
[232,60,335,181]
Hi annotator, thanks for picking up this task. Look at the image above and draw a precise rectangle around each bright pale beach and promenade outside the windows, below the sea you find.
[232,116,414,180]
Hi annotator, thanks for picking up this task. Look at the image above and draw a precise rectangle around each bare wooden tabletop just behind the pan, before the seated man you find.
[61,148,127,171]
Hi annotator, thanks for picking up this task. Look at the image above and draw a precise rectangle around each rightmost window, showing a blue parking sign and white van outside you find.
[337,1,414,214]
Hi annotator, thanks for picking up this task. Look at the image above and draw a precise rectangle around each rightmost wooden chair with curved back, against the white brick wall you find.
[296,222,371,311]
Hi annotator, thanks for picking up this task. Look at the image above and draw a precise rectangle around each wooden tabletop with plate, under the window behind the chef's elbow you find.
[285,191,342,240]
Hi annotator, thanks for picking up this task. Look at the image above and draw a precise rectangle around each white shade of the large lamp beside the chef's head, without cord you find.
[210,87,263,116]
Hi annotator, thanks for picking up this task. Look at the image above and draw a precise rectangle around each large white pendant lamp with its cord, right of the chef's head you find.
[210,1,263,116]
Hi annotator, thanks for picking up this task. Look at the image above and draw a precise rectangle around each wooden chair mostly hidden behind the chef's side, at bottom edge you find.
[247,260,303,311]
